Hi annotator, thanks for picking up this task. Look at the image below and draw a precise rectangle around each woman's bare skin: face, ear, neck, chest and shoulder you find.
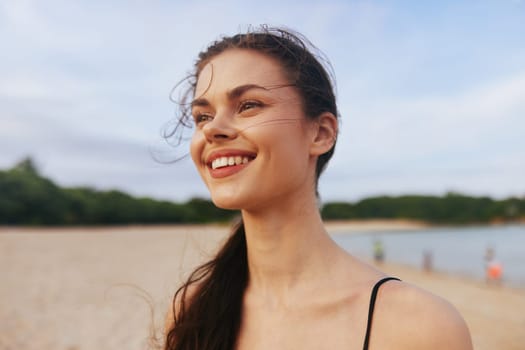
[187,49,472,350]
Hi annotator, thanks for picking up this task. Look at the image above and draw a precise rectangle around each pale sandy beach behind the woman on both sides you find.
[0,221,525,350]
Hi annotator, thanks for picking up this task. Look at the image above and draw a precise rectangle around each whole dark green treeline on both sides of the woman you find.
[0,159,525,225]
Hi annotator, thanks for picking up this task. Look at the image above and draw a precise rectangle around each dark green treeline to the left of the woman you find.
[0,159,237,225]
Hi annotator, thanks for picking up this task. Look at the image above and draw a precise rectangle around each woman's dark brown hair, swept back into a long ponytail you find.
[165,26,338,350]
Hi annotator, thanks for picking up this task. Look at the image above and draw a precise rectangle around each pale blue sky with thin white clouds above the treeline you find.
[0,0,525,201]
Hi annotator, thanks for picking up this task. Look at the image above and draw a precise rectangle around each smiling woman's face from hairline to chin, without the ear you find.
[191,49,316,210]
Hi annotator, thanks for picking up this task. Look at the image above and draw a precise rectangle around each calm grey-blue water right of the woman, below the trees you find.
[334,225,525,288]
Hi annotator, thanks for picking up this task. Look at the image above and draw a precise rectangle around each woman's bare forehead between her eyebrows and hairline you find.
[195,49,289,96]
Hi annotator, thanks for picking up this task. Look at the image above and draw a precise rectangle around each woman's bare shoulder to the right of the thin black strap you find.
[370,281,472,350]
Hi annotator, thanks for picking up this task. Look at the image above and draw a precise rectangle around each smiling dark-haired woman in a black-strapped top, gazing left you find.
[166,27,472,350]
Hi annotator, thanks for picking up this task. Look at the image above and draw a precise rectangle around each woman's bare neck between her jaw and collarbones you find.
[243,193,339,302]
